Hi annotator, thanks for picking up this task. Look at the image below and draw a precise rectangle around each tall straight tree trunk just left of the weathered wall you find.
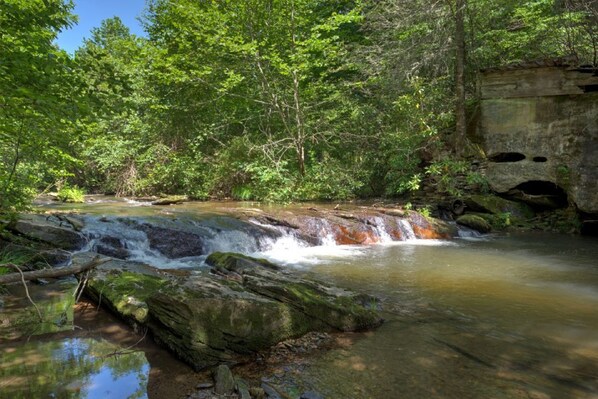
[453,0,467,155]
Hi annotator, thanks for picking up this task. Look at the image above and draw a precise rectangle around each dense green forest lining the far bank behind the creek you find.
[0,0,598,211]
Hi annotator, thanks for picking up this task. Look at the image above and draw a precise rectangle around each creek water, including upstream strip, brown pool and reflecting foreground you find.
[0,198,598,399]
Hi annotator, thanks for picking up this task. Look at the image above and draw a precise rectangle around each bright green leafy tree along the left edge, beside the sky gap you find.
[0,0,77,212]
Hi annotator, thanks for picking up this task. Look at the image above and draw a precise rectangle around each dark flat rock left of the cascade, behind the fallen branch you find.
[8,215,87,250]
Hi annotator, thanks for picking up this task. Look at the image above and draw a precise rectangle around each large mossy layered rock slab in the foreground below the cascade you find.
[73,253,382,370]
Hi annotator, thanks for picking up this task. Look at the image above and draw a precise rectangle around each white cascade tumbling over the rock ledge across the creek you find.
[77,214,438,268]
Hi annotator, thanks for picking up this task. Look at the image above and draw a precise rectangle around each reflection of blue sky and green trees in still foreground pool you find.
[0,338,149,399]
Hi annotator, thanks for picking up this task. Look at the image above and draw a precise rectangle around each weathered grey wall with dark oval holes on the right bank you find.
[478,64,598,214]
